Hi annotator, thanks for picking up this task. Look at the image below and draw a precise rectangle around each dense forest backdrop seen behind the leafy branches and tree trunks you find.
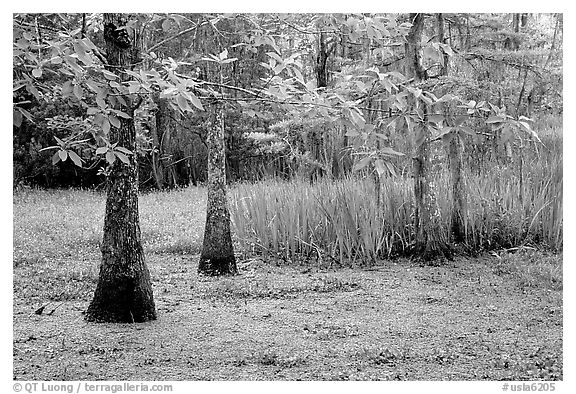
[13,14,562,185]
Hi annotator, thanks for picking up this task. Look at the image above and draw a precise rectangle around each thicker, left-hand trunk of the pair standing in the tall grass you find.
[405,14,452,261]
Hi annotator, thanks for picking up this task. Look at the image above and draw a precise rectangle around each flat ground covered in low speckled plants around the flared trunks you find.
[13,188,563,380]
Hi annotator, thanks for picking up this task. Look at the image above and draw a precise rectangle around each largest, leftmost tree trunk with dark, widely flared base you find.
[86,14,156,323]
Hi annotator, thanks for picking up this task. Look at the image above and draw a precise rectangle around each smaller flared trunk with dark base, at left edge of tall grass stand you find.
[198,103,237,275]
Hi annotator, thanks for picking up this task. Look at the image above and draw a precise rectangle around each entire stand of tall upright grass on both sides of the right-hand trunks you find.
[231,124,563,263]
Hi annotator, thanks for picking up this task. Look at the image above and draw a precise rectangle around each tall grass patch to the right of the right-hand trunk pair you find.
[466,149,563,250]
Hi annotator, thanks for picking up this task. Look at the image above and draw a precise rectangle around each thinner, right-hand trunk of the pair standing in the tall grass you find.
[436,13,466,243]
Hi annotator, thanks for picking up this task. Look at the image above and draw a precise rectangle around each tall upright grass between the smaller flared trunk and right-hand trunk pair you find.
[231,179,412,263]
